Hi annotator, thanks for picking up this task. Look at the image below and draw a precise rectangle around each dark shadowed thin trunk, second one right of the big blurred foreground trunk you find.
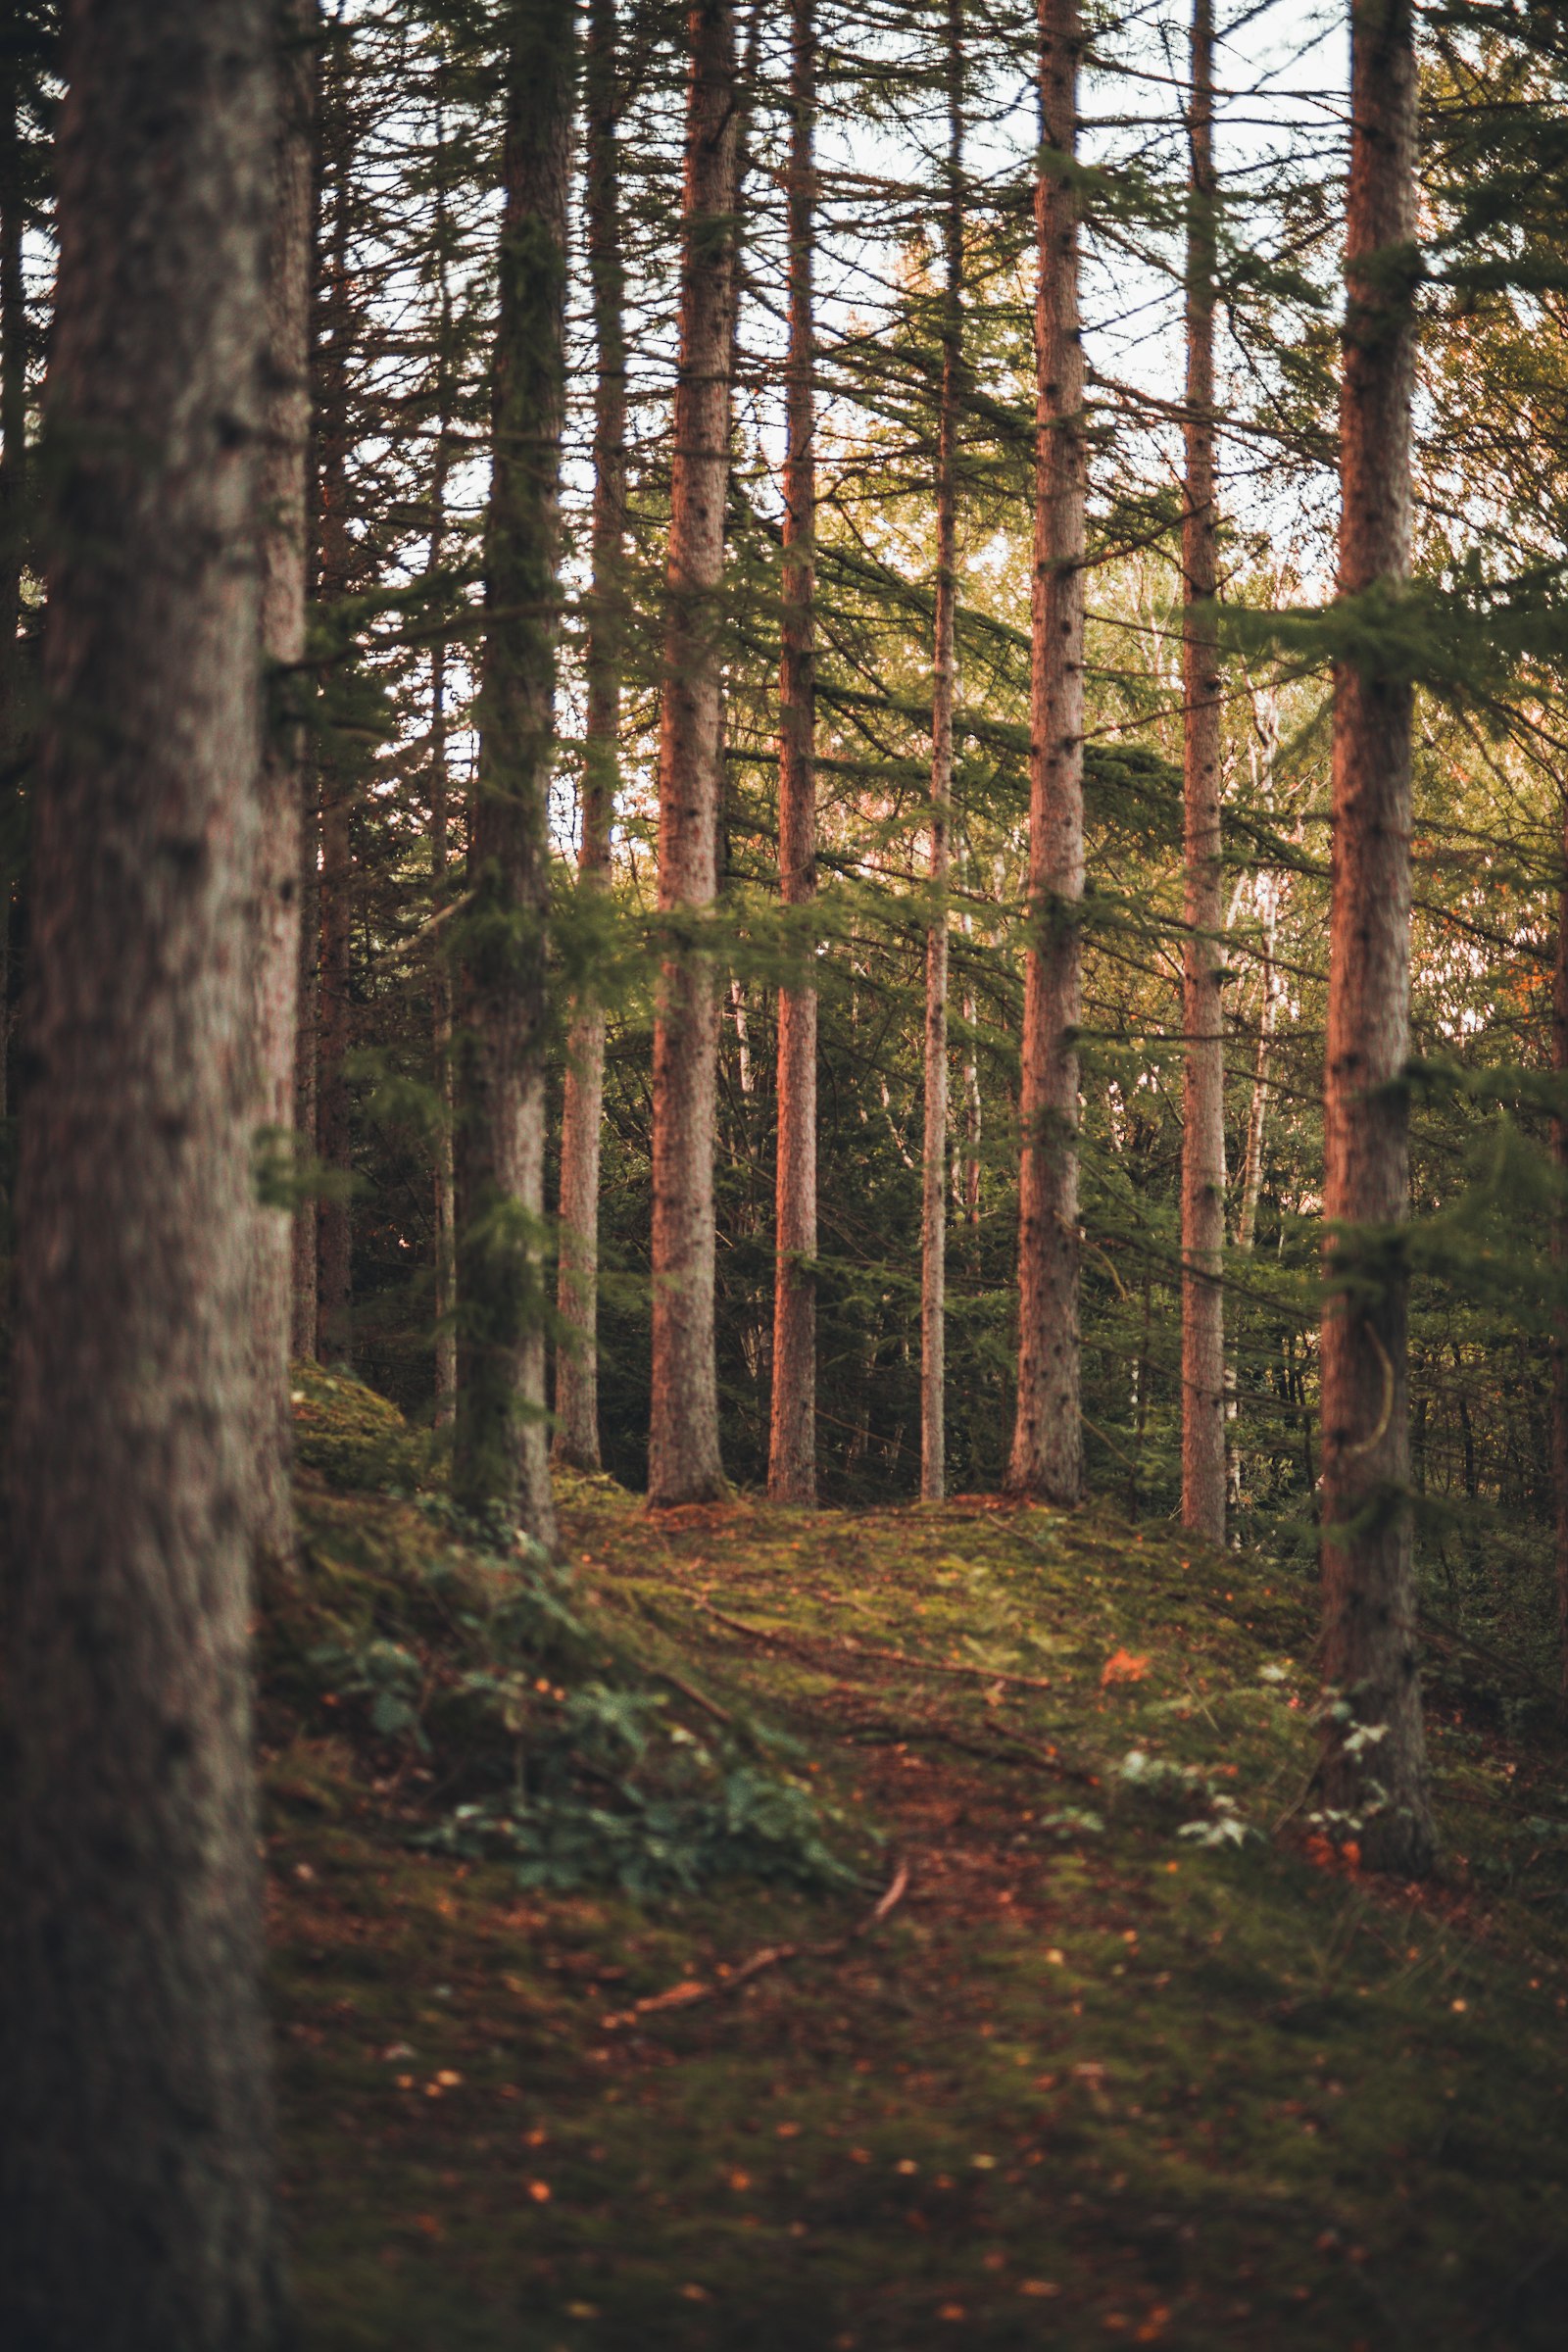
[315,7,355,1362]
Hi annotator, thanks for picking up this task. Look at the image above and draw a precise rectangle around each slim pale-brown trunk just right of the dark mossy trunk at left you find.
[555,0,625,1470]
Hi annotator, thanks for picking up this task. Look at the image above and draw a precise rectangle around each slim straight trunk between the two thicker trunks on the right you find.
[1183,0,1225,1543]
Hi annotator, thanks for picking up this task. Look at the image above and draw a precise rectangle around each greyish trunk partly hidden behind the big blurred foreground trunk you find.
[252,0,315,1559]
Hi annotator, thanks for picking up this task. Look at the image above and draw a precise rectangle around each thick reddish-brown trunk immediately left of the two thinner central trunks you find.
[649,0,738,1503]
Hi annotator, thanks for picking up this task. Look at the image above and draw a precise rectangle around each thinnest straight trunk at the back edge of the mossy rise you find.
[919,0,964,1503]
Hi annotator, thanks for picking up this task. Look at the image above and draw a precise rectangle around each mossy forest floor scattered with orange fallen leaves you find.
[275,1383,1568,2352]
